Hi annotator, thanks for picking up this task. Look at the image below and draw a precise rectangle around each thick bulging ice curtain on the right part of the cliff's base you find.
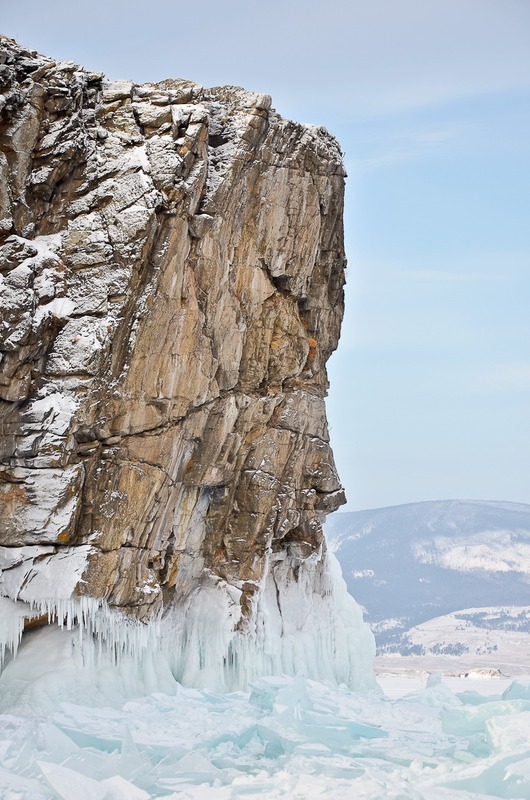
[161,553,375,691]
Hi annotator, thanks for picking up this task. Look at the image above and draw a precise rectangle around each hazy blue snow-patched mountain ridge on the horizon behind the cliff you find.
[326,500,530,654]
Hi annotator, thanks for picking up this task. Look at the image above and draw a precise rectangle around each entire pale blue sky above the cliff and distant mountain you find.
[5,0,530,510]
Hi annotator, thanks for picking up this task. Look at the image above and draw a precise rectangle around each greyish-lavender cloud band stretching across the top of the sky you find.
[2,0,530,116]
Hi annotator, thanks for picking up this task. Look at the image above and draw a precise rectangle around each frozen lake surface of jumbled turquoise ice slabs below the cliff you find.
[0,675,530,800]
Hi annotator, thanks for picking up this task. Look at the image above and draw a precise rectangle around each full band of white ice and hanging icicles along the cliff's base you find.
[0,553,375,690]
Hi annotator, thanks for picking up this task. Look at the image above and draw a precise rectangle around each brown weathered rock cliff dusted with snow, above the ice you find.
[0,38,360,688]
